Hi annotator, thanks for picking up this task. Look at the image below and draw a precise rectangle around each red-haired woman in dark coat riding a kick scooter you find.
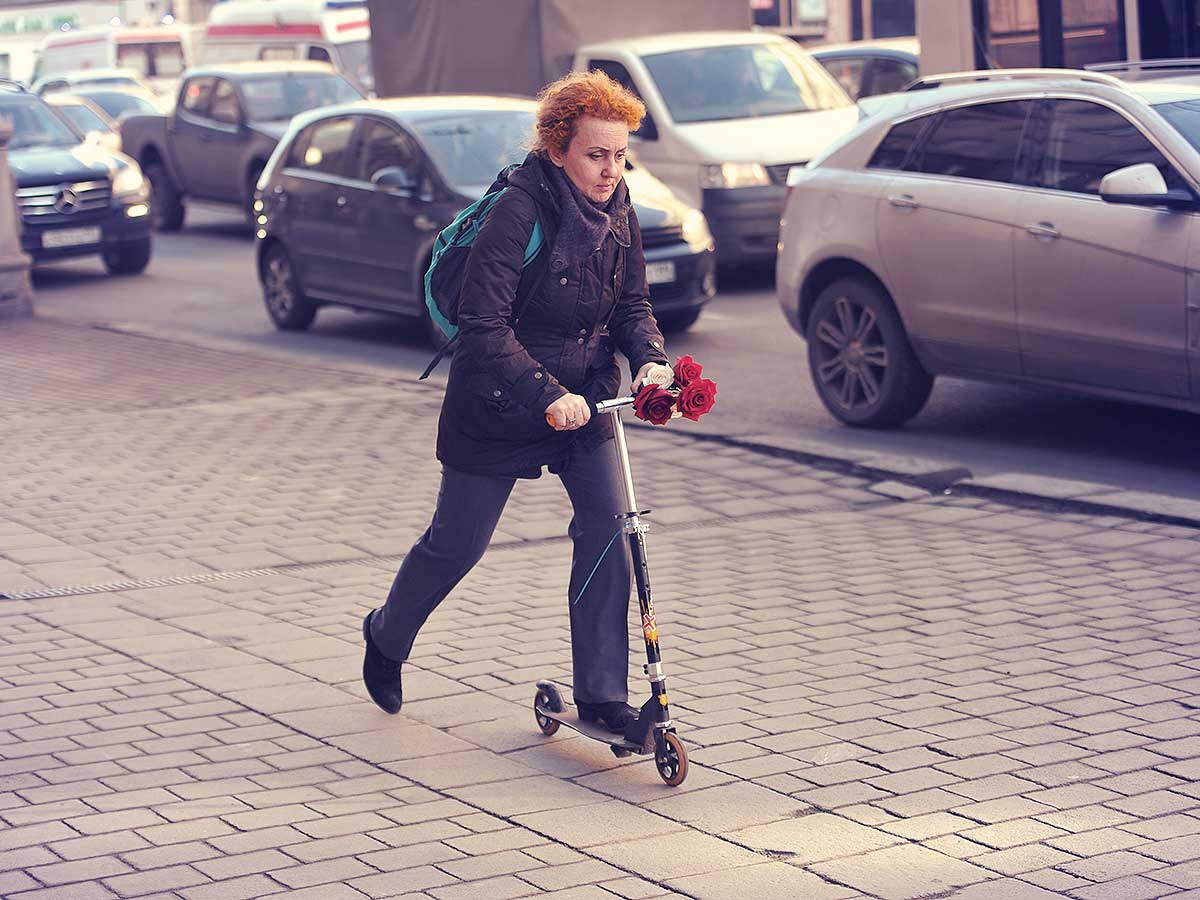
[362,72,667,733]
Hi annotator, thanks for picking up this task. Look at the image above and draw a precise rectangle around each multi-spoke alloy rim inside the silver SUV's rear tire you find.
[815,296,888,412]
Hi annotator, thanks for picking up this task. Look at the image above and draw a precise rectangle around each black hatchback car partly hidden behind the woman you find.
[256,96,716,343]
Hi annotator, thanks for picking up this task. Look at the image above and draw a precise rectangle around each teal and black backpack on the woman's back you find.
[421,166,546,379]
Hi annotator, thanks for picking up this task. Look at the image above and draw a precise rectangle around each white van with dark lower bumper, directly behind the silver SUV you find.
[574,31,859,265]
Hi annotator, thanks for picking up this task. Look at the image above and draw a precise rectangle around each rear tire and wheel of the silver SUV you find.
[805,277,934,428]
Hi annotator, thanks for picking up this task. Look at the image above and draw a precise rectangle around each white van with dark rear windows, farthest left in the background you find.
[31,25,187,92]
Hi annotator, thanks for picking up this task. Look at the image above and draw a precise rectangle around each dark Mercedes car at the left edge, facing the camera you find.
[0,83,152,274]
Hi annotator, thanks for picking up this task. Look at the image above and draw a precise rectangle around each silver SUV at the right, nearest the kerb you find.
[776,70,1200,427]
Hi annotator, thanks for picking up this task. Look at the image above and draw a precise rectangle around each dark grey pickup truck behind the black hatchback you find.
[121,62,362,232]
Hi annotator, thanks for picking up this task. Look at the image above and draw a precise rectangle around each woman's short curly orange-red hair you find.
[533,70,646,154]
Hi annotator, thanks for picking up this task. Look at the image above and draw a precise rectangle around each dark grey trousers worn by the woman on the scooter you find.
[371,440,631,703]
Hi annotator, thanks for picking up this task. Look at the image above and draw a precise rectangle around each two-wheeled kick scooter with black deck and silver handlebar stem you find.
[533,397,688,787]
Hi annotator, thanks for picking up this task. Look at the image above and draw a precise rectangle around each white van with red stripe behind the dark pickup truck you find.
[202,0,374,91]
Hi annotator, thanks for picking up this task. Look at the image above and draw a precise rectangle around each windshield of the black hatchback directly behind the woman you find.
[414,109,534,193]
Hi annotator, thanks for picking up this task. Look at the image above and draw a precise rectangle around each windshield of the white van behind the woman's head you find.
[642,41,851,125]
